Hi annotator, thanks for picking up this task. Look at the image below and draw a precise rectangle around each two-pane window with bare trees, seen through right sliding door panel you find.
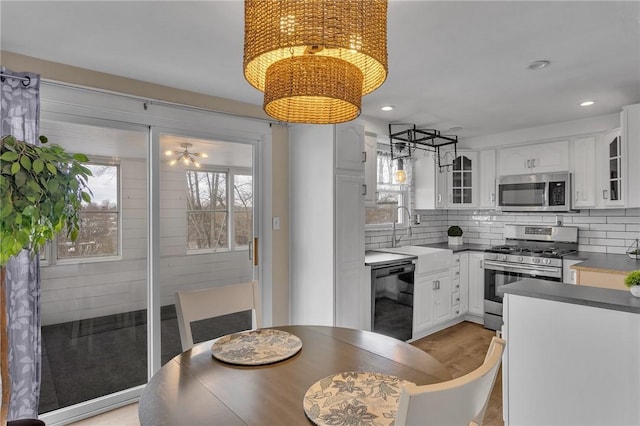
[187,170,253,250]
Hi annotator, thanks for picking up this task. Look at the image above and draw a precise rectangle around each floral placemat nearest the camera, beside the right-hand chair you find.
[303,372,411,426]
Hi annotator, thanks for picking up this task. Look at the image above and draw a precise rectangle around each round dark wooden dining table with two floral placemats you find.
[138,326,451,426]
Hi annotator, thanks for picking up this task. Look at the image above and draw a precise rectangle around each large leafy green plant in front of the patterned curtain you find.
[0,136,91,421]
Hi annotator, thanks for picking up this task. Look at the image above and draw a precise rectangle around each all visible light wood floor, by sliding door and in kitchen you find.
[67,322,504,426]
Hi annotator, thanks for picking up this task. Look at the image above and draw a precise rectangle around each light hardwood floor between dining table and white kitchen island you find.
[412,321,504,426]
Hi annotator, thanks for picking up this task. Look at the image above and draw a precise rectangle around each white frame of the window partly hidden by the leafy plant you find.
[41,155,123,266]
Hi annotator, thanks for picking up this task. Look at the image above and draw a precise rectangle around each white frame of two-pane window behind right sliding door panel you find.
[185,164,255,255]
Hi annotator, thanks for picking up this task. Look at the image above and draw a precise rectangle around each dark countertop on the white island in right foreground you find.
[498,278,640,314]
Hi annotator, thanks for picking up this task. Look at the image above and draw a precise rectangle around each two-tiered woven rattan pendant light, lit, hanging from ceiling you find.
[243,0,387,124]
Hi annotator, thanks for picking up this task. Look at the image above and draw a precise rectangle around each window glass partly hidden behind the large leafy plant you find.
[55,163,120,259]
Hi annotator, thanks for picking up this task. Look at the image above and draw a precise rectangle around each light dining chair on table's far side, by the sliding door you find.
[176,281,261,351]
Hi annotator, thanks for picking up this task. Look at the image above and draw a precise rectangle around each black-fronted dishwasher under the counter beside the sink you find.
[371,260,415,341]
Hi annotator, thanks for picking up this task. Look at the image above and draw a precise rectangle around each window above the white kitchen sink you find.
[365,150,411,225]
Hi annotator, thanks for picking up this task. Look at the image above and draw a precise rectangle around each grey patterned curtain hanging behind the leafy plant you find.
[0,67,41,420]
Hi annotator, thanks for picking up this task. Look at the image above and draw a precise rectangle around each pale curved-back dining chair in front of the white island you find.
[395,337,506,426]
